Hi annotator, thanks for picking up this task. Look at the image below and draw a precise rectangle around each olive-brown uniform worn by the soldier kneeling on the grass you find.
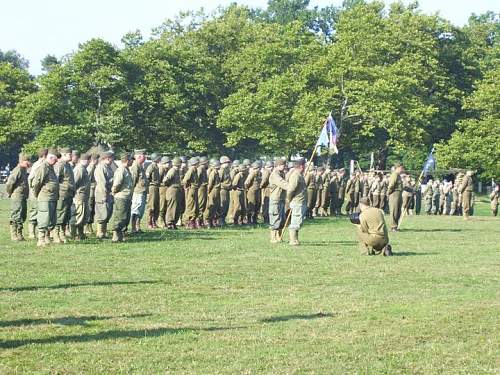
[358,207,389,253]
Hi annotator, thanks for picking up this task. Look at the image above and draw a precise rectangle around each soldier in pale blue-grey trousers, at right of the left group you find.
[129,150,148,234]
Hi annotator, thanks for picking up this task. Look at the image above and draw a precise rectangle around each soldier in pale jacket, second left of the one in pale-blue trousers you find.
[94,151,113,239]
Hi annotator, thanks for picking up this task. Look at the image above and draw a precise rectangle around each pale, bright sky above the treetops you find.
[0,0,500,75]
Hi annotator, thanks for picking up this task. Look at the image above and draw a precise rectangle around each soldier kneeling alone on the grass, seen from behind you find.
[358,198,392,256]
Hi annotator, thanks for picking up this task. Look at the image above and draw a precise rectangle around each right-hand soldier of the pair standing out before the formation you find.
[286,158,307,246]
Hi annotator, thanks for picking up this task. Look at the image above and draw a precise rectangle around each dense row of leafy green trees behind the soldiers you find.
[0,0,500,177]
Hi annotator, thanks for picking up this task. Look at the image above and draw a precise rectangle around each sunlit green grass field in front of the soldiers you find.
[0,195,500,374]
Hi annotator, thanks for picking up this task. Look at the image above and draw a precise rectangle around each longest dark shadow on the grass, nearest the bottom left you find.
[0,327,245,349]
